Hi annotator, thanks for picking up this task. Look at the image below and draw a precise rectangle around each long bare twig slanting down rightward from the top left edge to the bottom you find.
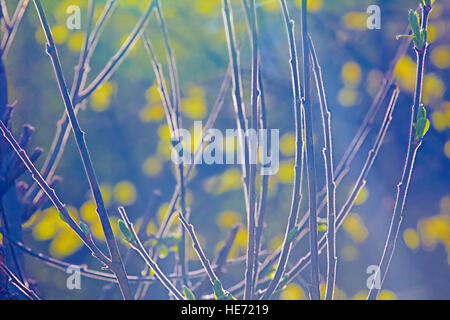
[34,0,132,299]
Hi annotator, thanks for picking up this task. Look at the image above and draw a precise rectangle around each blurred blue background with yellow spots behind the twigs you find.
[0,0,450,299]
